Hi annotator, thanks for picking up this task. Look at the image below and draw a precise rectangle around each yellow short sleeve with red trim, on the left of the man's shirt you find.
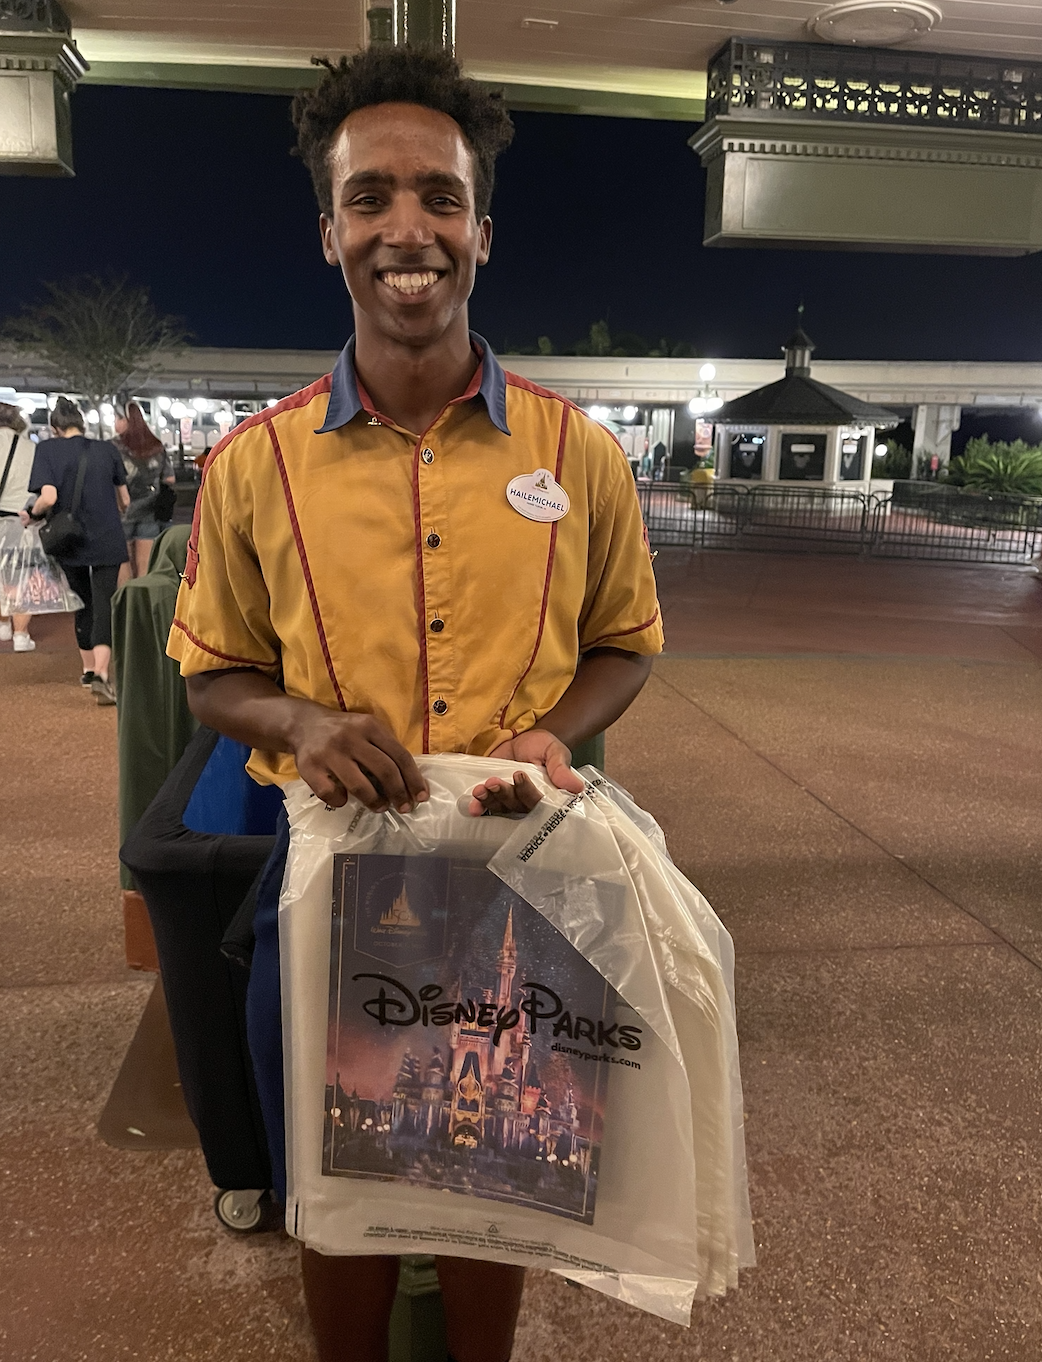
[166,455,282,680]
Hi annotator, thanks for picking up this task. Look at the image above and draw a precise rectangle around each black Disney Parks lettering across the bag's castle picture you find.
[351,974,640,1050]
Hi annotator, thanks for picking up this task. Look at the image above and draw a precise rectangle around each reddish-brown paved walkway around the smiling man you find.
[0,552,1042,1362]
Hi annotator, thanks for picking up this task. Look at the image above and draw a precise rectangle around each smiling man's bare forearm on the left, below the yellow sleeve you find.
[187,671,321,752]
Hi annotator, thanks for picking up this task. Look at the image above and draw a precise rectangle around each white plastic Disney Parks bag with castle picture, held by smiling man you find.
[279,755,753,1324]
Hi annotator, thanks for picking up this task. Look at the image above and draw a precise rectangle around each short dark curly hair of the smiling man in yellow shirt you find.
[293,46,514,218]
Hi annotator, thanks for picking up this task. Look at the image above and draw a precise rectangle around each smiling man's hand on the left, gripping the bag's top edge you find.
[293,707,430,813]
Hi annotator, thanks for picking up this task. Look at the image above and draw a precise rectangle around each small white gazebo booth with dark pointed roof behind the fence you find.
[714,327,900,492]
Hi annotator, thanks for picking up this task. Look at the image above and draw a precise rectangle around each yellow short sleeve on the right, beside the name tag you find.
[579,449,662,656]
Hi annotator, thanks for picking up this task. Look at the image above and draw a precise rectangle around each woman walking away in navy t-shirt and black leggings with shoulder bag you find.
[29,398,131,704]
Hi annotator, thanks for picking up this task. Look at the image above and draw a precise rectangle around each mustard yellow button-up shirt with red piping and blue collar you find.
[168,336,662,783]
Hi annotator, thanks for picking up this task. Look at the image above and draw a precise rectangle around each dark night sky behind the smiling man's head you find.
[0,86,1042,361]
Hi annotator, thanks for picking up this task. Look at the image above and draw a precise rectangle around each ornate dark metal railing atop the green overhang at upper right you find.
[706,38,1042,132]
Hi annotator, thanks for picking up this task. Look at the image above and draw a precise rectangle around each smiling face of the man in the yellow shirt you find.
[320,104,492,347]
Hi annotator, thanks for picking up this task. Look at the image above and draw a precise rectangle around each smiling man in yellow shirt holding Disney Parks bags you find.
[169,49,662,1362]
